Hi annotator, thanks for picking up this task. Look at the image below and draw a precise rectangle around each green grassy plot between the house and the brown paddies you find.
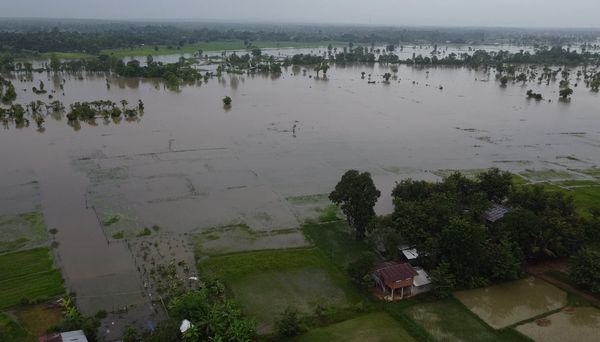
[404,299,523,341]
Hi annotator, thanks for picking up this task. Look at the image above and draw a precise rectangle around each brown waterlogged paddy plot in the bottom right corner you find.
[516,307,600,342]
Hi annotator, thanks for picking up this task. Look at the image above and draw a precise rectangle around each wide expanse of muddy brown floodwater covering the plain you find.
[0,57,600,332]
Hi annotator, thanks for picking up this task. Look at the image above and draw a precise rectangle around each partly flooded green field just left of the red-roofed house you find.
[200,248,364,333]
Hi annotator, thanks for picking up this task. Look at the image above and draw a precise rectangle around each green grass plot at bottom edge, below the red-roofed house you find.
[297,312,414,342]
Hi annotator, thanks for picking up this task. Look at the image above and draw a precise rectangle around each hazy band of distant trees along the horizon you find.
[0,22,598,54]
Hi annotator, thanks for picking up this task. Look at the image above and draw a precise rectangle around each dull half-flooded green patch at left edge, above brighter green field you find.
[0,211,48,254]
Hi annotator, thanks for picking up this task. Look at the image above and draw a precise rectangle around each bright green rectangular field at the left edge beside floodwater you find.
[0,248,64,308]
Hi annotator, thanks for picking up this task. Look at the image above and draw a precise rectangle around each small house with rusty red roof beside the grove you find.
[372,262,418,300]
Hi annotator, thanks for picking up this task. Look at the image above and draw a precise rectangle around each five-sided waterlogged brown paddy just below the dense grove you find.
[455,277,567,329]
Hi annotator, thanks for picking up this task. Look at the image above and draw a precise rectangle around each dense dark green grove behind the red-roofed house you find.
[380,169,591,296]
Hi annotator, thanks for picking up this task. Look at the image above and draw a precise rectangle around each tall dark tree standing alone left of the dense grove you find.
[329,170,381,239]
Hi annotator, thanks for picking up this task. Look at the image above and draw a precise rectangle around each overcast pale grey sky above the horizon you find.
[0,0,600,27]
